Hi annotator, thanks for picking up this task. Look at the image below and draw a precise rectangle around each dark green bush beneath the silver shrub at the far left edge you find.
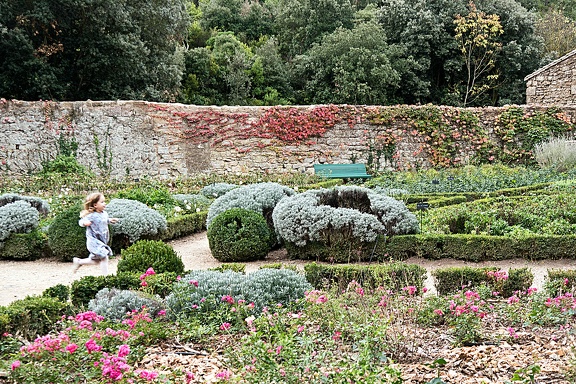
[0,229,50,260]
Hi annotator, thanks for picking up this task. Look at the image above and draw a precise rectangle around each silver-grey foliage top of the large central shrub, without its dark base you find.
[272,186,418,246]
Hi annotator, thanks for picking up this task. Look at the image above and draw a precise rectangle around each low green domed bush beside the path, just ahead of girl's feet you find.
[118,240,184,274]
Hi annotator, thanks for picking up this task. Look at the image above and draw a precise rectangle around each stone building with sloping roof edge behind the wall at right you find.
[524,49,576,106]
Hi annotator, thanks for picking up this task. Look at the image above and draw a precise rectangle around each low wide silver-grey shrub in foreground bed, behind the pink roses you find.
[166,269,313,318]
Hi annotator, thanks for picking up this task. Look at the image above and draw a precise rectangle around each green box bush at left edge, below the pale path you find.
[0,296,68,340]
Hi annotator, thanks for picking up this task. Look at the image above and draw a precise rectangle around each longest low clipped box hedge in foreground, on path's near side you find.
[304,262,426,291]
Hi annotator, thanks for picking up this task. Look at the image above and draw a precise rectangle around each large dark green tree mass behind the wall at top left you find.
[0,0,188,101]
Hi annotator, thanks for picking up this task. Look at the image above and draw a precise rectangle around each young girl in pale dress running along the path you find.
[72,192,118,276]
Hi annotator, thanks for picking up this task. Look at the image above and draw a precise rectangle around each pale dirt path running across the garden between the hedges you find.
[0,232,576,306]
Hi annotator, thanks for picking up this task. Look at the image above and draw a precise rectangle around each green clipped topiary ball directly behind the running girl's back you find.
[48,205,89,261]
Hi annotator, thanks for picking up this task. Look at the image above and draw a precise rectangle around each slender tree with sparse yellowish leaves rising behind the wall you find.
[454,2,503,106]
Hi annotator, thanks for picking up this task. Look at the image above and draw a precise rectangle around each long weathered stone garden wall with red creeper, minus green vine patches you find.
[0,100,576,178]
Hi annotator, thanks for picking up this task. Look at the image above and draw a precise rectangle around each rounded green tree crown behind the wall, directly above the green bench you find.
[296,22,402,105]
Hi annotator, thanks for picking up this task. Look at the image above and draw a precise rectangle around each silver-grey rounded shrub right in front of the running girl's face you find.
[106,199,167,243]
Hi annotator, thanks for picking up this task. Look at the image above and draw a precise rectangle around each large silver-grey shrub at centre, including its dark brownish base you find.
[272,186,419,262]
